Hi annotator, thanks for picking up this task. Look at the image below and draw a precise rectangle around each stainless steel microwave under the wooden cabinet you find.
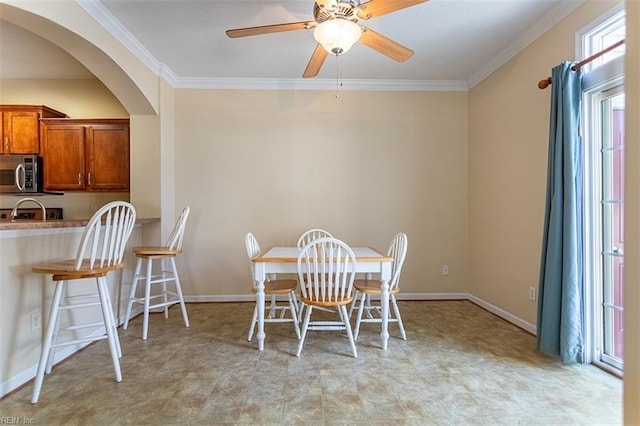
[0,155,42,194]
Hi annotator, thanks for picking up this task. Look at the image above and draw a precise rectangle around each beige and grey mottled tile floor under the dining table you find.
[0,301,622,425]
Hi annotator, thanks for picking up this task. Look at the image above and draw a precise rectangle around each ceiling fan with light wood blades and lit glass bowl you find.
[226,0,428,78]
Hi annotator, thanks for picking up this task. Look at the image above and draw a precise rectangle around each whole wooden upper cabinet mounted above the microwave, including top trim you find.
[0,105,66,154]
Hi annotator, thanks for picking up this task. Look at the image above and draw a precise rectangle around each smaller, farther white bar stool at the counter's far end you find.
[122,206,191,340]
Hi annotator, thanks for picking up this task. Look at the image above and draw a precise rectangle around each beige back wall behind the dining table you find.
[175,90,467,297]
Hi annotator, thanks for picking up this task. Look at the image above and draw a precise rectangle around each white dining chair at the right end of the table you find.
[349,232,407,340]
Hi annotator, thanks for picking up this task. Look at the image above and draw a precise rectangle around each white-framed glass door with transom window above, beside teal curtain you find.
[582,6,626,374]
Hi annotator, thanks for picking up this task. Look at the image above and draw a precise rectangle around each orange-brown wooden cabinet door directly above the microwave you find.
[2,111,40,154]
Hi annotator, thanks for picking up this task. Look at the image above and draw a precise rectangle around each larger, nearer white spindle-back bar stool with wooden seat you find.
[31,201,136,404]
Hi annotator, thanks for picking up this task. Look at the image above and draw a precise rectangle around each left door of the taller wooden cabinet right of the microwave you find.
[42,124,86,191]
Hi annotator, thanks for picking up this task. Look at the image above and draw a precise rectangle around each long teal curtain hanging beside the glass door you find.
[537,62,584,363]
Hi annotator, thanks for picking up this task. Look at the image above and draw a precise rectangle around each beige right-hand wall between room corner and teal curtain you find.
[469,1,617,324]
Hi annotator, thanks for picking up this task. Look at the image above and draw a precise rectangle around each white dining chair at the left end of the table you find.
[244,232,300,342]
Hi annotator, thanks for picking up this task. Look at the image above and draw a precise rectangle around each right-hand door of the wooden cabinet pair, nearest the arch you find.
[86,124,129,191]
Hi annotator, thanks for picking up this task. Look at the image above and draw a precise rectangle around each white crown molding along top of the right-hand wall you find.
[467,0,585,89]
